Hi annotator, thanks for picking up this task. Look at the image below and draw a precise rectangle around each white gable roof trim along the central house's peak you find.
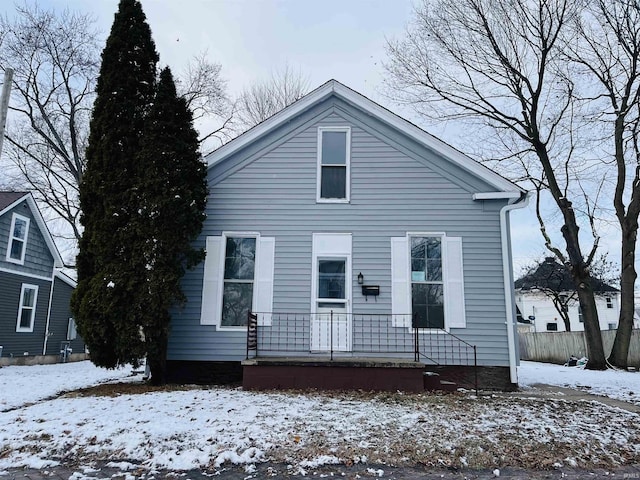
[205,80,526,196]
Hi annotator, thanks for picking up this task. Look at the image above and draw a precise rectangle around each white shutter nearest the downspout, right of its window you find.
[444,237,467,328]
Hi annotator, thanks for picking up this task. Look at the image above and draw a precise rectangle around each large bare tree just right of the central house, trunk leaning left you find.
[386,0,606,369]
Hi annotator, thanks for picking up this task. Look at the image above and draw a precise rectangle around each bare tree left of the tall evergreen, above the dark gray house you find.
[0,4,99,244]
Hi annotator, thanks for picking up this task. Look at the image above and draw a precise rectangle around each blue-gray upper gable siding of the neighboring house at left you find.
[0,200,53,278]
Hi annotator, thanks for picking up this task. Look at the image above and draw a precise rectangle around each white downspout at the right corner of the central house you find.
[500,193,529,384]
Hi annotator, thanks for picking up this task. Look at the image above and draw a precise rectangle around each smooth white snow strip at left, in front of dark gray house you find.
[0,362,139,411]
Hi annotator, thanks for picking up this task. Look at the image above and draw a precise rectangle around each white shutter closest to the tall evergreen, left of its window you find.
[200,237,223,325]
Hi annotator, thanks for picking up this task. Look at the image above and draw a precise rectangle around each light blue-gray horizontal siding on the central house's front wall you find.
[169,98,508,365]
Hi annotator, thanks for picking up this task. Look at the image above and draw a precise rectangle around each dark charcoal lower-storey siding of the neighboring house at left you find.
[0,272,51,357]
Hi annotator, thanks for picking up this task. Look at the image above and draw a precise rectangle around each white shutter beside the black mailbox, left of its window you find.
[391,237,411,327]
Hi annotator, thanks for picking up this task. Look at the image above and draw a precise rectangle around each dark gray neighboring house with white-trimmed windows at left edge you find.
[0,192,84,364]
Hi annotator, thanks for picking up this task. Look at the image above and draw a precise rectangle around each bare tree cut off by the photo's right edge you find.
[565,0,640,368]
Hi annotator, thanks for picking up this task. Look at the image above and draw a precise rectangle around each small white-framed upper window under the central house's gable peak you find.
[317,127,351,203]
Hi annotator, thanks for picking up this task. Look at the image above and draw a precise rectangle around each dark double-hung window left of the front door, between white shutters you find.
[220,237,256,327]
